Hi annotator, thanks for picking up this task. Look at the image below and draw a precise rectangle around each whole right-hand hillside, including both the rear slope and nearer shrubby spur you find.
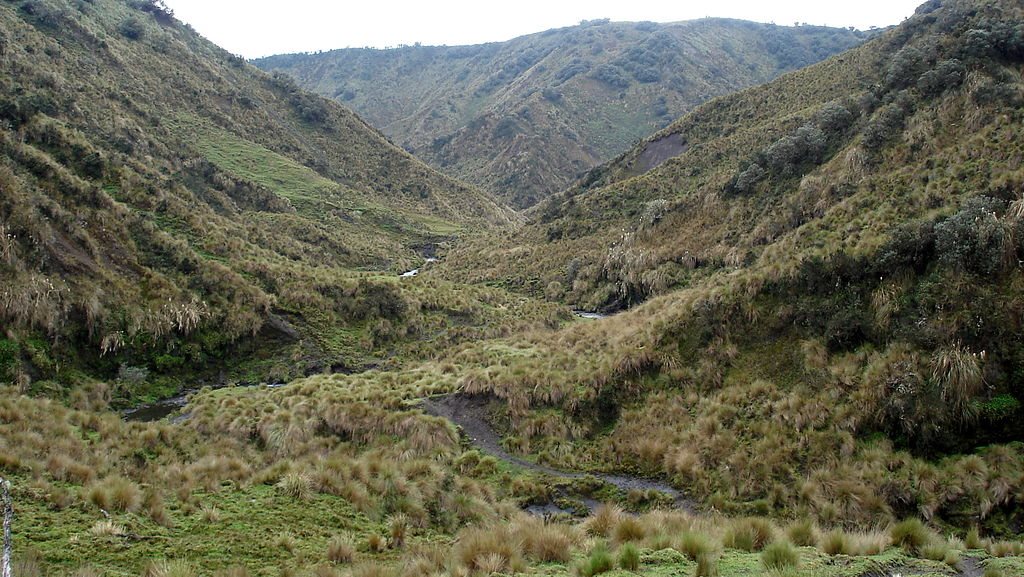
[439,0,1024,531]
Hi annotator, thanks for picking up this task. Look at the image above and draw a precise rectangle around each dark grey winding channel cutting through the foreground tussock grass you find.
[421,395,694,511]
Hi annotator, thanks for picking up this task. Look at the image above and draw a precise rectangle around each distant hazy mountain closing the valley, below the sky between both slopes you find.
[253,18,865,208]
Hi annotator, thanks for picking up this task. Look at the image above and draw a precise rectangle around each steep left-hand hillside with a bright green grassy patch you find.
[0,0,520,399]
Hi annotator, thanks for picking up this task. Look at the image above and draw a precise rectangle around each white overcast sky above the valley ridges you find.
[165,0,924,58]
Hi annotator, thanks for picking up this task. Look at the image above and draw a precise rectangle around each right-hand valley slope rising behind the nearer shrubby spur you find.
[449,2,1022,315]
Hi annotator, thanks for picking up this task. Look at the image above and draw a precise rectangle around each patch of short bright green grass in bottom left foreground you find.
[14,485,384,575]
